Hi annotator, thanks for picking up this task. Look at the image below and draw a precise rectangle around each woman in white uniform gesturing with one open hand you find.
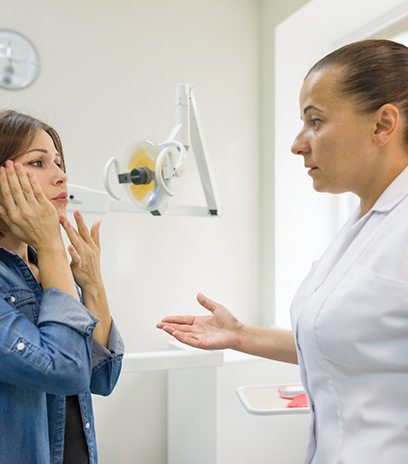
[157,40,408,464]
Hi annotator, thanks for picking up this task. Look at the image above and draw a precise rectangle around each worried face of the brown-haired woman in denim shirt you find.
[13,130,68,214]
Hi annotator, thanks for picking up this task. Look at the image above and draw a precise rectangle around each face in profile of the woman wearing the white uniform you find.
[292,67,378,196]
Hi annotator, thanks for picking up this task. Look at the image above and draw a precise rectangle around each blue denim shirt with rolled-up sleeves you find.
[0,248,124,464]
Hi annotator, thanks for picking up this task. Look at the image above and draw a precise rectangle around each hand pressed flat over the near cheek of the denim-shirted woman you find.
[0,160,62,250]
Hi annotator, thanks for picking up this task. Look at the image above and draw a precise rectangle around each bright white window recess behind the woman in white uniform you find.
[274,0,408,326]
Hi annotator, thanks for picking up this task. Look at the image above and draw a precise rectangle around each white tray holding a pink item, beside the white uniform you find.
[236,385,310,416]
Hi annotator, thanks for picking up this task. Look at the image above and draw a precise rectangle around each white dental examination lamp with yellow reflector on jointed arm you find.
[69,84,220,216]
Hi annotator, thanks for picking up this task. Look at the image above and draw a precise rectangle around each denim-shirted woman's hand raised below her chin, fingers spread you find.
[60,211,102,290]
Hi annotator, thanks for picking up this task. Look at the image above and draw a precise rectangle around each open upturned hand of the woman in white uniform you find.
[156,293,242,349]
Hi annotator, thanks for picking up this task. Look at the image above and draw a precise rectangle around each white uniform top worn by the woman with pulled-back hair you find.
[291,168,408,464]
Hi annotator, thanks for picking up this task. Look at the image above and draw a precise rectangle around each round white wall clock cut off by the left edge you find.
[0,29,40,89]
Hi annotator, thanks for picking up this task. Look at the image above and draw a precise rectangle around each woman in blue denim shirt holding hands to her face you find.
[0,110,123,464]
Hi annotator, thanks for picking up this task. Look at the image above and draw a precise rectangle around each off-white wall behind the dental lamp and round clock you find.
[0,0,259,464]
